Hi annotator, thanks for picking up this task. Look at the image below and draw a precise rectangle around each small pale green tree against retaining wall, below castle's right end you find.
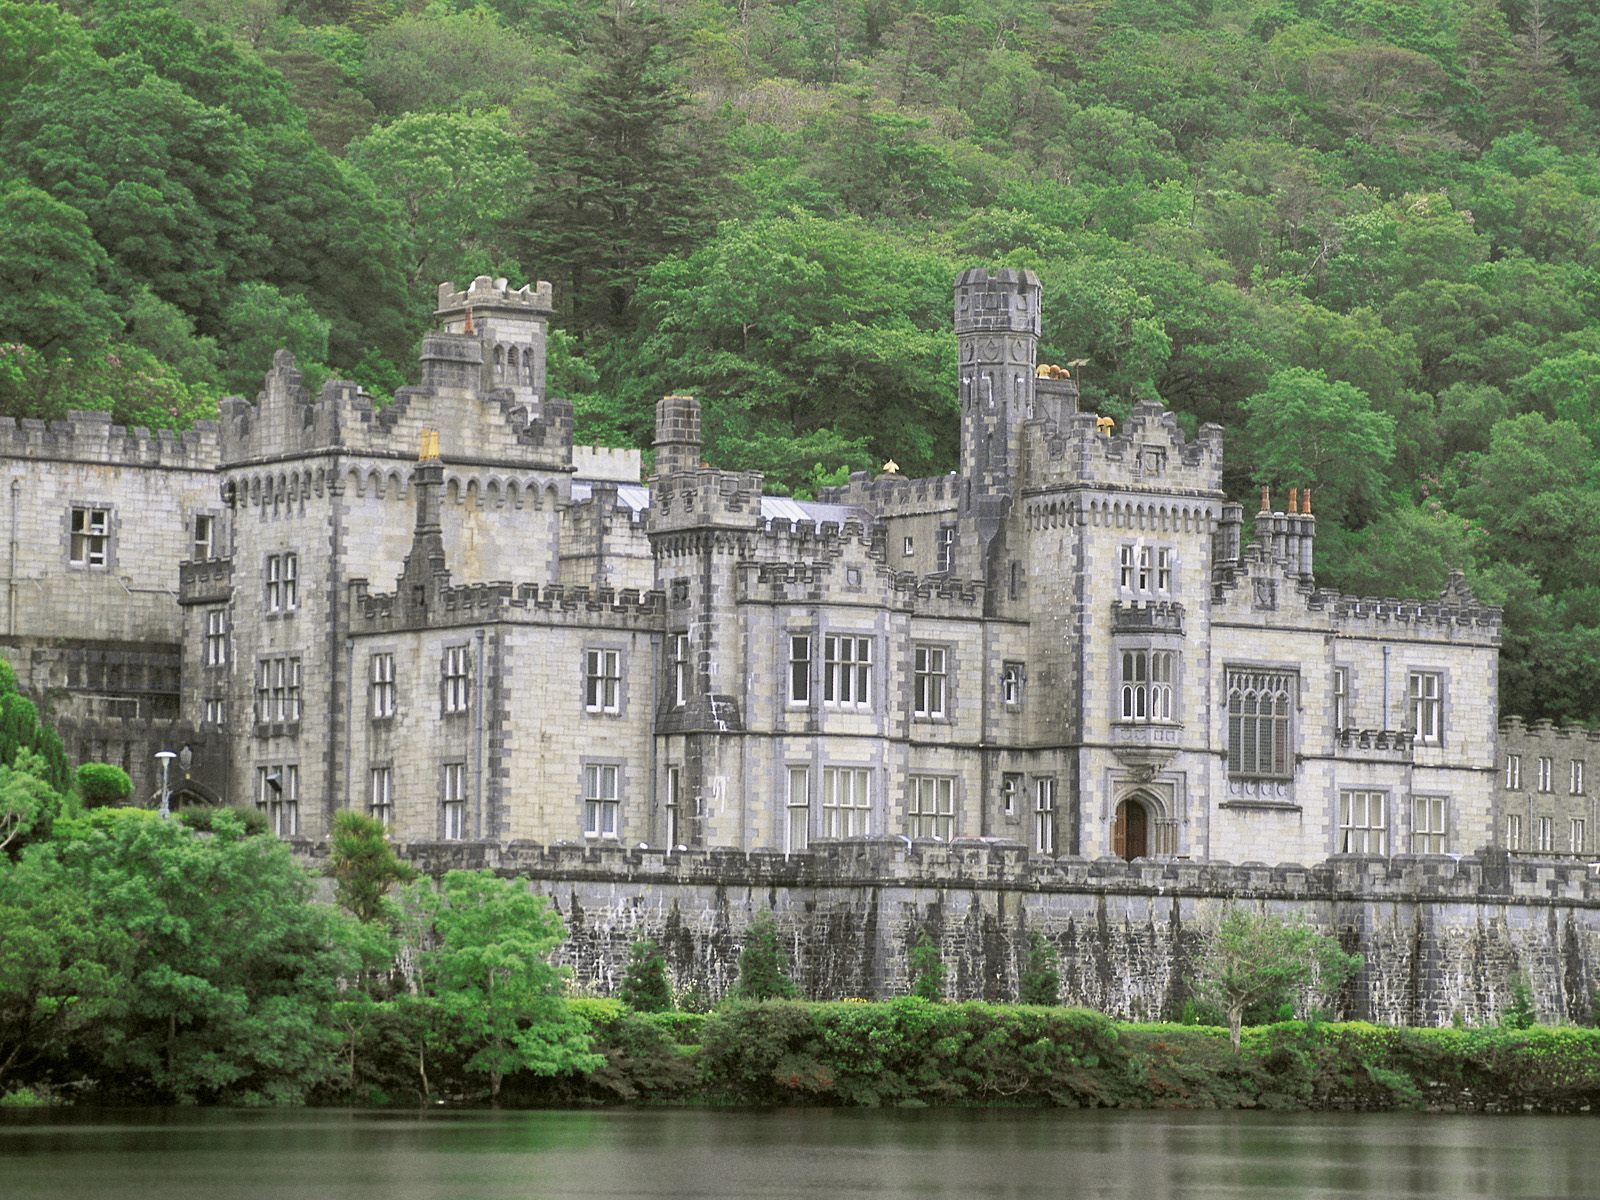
[1190,906,1362,1054]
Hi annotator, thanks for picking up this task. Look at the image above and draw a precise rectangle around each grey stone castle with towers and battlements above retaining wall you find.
[0,269,1536,862]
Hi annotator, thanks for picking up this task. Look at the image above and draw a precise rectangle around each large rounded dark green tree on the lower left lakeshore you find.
[31,808,355,1102]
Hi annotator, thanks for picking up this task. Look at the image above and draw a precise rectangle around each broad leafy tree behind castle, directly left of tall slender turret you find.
[627,214,958,486]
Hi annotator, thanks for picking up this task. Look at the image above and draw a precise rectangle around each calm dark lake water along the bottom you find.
[0,1109,1600,1200]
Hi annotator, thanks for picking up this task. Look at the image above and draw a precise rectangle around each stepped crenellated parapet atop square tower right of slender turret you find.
[1022,402,1222,494]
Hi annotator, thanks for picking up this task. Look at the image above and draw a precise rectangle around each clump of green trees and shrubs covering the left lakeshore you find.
[0,684,603,1104]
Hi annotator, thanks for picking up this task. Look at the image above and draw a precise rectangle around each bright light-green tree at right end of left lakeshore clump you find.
[422,870,605,1101]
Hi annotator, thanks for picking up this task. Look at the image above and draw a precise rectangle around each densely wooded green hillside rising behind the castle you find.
[0,0,1600,720]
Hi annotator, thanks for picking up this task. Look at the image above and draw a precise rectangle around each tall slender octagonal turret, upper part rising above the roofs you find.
[955,267,1040,496]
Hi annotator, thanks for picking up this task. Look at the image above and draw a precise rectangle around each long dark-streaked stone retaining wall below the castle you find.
[302,840,1600,1026]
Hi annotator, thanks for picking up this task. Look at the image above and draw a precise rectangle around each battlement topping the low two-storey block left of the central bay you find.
[350,579,666,634]
